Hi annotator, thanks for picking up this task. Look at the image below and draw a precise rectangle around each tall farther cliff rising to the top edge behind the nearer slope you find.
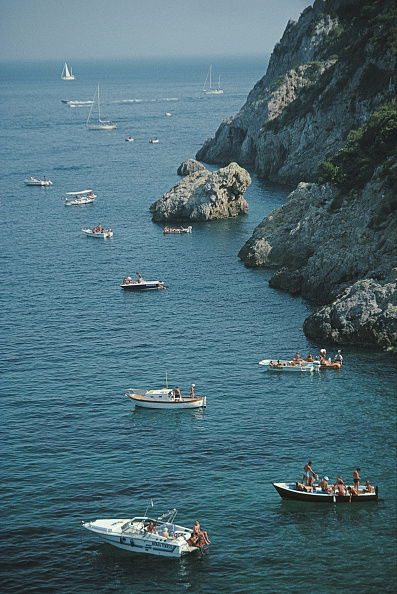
[196,0,397,183]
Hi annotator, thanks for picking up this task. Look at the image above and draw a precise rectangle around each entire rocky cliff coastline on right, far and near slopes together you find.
[197,0,397,350]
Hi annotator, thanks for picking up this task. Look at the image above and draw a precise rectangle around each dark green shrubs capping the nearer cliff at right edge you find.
[318,103,397,190]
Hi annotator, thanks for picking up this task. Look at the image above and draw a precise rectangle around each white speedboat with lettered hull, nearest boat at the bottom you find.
[82,509,200,557]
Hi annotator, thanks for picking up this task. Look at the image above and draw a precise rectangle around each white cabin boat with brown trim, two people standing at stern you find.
[125,388,207,410]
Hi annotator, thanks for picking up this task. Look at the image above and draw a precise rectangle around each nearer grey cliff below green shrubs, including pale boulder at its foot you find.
[239,171,397,350]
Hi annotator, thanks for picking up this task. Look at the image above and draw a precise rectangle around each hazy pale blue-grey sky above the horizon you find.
[0,0,311,60]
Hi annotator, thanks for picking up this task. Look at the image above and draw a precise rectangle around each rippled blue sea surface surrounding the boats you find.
[0,56,397,594]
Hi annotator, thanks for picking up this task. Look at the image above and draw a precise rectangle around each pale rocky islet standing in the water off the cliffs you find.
[150,163,251,222]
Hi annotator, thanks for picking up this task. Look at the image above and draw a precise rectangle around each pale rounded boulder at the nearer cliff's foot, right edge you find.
[303,279,397,351]
